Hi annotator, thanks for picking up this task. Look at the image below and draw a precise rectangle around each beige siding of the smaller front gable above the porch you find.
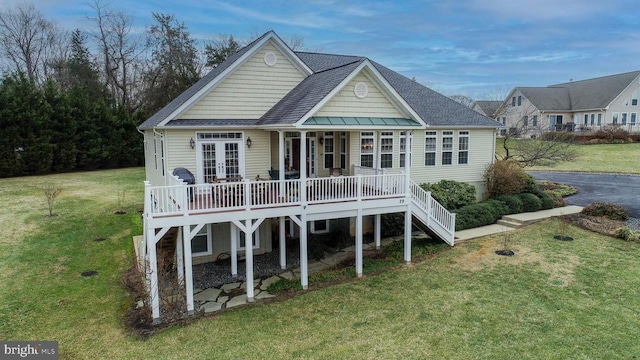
[314,73,407,118]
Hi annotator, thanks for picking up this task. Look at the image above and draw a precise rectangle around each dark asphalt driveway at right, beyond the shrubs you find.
[530,171,640,218]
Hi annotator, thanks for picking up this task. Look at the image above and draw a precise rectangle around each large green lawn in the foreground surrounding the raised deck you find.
[0,169,640,359]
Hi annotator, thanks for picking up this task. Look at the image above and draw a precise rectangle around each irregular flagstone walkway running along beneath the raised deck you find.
[193,231,426,313]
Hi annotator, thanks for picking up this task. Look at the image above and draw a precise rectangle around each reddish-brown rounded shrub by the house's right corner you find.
[484,160,530,198]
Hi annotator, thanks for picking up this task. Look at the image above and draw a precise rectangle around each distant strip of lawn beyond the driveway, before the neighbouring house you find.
[496,139,640,174]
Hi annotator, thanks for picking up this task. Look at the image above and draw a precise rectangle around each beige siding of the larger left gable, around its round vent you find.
[179,42,304,119]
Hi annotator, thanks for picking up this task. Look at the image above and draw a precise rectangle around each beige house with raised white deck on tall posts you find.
[139,31,499,319]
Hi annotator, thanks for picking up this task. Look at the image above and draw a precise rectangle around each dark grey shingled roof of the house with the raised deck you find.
[140,31,500,129]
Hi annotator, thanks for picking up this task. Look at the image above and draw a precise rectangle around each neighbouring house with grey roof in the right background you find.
[493,71,640,136]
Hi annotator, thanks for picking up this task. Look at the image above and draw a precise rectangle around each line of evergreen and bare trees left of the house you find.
[0,0,248,177]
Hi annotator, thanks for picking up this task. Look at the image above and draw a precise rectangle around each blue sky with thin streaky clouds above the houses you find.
[5,0,640,100]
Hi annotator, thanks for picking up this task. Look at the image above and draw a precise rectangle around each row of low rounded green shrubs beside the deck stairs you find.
[455,190,563,231]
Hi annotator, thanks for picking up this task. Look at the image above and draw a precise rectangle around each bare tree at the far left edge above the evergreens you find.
[0,4,64,83]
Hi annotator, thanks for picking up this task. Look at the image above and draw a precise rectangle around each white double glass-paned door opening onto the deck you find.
[196,140,242,183]
